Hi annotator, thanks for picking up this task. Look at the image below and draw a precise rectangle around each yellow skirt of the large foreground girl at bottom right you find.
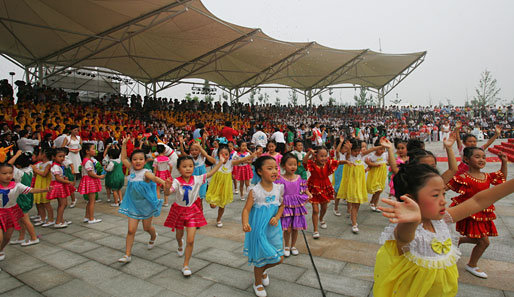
[373,240,459,297]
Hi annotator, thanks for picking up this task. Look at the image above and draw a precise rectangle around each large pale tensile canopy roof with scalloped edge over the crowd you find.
[0,0,426,90]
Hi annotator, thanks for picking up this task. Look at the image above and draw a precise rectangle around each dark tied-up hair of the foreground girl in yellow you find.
[393,163,440,201]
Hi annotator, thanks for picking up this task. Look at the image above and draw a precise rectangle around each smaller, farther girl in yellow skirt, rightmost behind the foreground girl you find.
[365,138,388,212]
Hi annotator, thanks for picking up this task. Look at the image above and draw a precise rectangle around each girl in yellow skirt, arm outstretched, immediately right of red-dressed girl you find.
[337,139,380,233]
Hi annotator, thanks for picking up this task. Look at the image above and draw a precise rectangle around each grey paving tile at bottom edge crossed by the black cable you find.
[296,271,372,297]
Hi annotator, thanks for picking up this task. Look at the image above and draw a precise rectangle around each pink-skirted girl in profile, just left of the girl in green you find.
[79,143,105,224]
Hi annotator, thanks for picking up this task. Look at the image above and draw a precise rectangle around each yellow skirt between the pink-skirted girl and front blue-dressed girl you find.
[205,171,234,208]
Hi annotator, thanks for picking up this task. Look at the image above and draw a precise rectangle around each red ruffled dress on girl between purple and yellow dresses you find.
[307,160,339,203]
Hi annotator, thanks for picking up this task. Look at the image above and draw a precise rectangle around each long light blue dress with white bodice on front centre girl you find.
[243,183,284,267]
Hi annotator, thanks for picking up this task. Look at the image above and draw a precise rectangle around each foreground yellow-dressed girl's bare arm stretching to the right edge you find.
[448,179,514,222]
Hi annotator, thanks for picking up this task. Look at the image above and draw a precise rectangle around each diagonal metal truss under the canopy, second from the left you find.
[153,29,260,92]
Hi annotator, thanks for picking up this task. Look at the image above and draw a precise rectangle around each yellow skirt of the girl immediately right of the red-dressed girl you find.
[336,165,368,204]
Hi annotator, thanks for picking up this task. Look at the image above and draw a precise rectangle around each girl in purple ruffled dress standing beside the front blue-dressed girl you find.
[275,153,312,257]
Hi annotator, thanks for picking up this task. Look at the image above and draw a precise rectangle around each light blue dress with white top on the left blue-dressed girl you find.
[118,168,163,220]
